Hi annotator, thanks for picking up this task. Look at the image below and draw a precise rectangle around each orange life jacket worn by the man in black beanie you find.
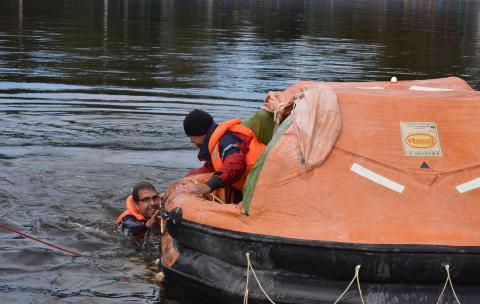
[208,118,265,191]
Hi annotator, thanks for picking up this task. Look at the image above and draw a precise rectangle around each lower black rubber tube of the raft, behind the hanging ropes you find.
[162,245,480,304]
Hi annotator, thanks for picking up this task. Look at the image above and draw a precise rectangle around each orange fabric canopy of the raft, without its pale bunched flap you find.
[167,77,480,246]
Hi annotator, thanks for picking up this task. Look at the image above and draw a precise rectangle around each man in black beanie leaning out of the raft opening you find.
[183,110,265,197]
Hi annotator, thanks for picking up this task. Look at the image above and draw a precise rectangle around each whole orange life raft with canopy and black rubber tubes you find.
[162,77,480,303]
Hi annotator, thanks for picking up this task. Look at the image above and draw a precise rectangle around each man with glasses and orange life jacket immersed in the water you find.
[115,182,164,239]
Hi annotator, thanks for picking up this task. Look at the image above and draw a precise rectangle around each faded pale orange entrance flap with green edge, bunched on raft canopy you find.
[243,84,341,213]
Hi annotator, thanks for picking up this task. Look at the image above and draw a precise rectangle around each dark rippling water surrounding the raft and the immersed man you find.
[0,0,480,303]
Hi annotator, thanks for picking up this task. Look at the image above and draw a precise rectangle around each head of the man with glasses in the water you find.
[132,182,161,220]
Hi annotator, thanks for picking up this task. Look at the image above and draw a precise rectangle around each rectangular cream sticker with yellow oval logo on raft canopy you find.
[400,121,442,156]
